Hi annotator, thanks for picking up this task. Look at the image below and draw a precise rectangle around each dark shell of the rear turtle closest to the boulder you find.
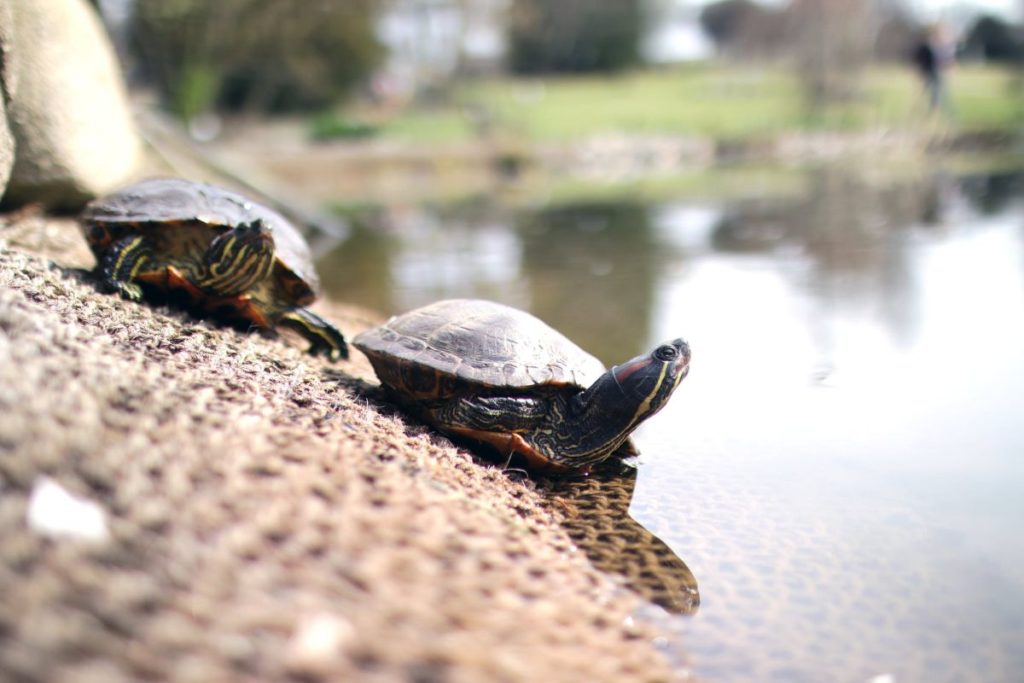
[82,178,319,305]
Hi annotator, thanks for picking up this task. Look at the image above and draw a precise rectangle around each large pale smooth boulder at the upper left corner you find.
[0,0,140,209]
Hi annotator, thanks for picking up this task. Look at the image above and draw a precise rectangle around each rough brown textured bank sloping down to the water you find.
[0,215,688,683]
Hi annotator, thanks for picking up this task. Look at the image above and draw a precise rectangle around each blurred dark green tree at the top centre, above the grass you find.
[509,0,643,74]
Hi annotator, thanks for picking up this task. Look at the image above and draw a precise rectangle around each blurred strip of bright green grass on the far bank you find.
[370,63,1024,143]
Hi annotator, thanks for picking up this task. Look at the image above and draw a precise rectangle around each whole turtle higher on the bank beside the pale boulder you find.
[80,178,348,361]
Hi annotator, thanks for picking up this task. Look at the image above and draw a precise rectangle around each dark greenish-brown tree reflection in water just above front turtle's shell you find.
[518,202,659,364]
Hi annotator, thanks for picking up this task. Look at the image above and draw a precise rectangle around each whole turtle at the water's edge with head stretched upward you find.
[352,299,690,473]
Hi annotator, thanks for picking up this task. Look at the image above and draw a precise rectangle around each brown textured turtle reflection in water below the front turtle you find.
[537,460,700,614]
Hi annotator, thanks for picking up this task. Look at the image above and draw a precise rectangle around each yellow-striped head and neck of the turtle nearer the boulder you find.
[196,219,274,297]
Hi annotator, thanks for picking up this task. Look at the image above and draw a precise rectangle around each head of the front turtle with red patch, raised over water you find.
[608,339,690,429]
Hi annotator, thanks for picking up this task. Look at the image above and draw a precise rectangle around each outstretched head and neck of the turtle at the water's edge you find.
[564,339,690,468]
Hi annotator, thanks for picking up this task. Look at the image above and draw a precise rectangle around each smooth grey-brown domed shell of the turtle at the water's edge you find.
[353,299,605,392]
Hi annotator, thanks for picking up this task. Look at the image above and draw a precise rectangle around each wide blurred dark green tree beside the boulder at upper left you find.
[131,0,384,121]
